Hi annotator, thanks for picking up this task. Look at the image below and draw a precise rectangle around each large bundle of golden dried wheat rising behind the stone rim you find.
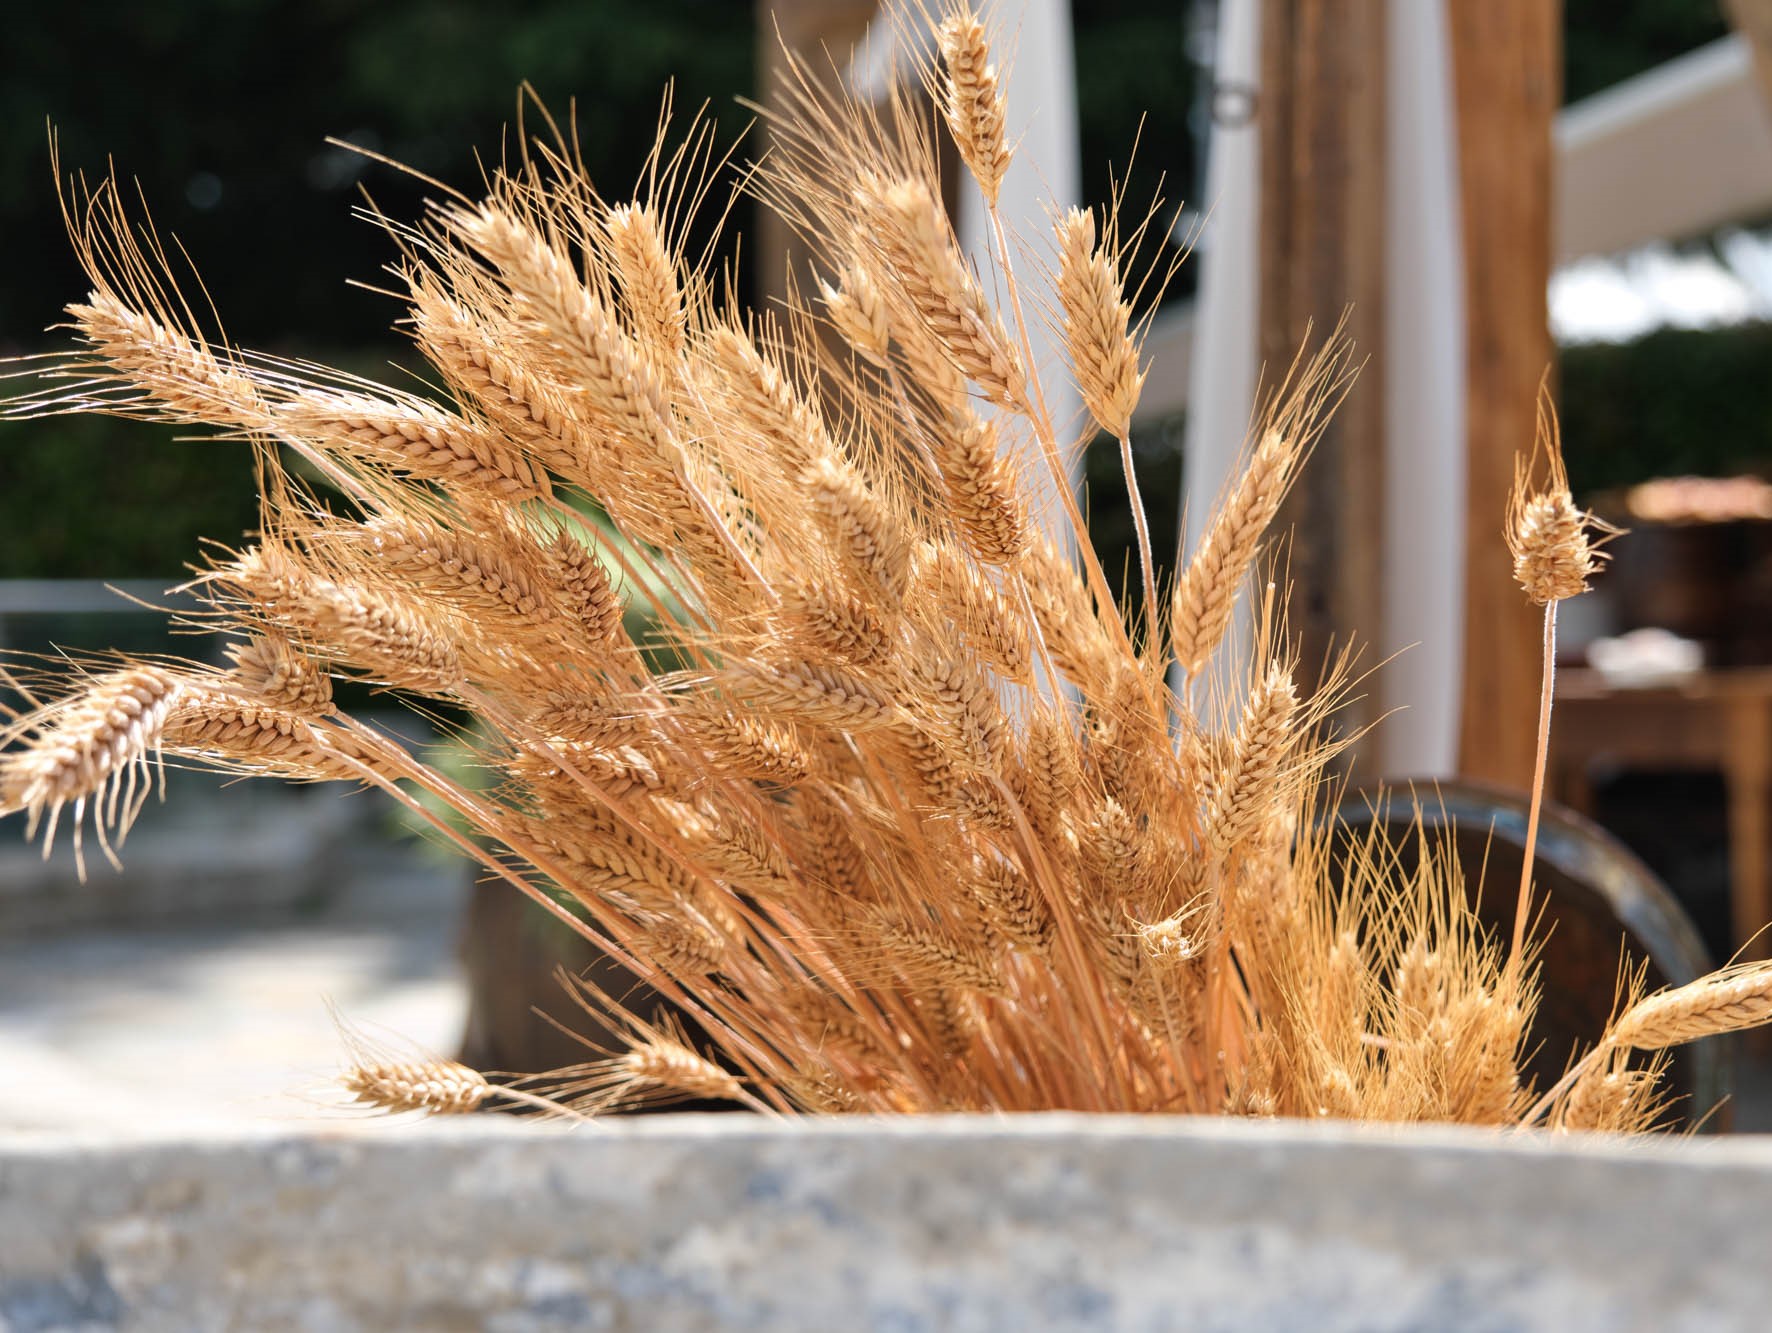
[0,11,1768,1127]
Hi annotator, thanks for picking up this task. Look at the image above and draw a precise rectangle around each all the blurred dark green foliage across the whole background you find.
[0,0,1765,581]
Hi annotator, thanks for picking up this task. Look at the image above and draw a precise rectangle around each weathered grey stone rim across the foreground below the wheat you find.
[0,1115,1772,1333]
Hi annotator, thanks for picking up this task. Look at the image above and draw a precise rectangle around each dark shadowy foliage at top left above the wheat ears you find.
[0,0,753,351]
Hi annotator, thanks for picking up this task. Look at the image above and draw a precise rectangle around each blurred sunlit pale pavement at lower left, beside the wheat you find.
[0,829,468,1133]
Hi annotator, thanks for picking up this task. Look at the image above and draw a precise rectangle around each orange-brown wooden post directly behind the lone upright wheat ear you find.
[1446,0,1563,787]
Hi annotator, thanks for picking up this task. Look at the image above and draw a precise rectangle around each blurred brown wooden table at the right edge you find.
[1551,667,1772,957]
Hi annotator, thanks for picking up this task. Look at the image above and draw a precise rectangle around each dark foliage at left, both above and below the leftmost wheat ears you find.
[0,0,753,578]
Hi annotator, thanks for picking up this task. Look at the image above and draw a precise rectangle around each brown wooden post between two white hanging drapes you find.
[1258,0,1387,751]
